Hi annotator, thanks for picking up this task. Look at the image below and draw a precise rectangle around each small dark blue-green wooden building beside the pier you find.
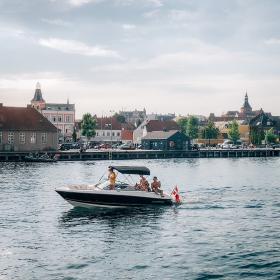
[141,130,190,150]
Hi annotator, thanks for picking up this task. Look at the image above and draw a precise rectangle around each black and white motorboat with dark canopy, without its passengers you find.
[55,166,174,208]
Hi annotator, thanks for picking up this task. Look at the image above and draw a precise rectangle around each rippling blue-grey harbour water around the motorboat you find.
[0,158,280,280]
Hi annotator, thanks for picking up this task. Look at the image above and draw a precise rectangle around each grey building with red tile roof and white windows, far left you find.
[0,103,58,151]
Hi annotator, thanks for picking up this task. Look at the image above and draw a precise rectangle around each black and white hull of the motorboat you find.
[56,189,173,208]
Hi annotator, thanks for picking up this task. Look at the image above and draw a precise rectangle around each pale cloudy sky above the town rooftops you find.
[0,0,280,117]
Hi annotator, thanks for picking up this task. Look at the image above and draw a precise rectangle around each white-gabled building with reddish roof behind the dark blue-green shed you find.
[133,119,180,144]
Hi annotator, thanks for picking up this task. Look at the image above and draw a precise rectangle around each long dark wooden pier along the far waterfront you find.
[0,149,280,162]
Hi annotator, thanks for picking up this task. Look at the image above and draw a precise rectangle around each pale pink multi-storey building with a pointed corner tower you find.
[31,83,75,142]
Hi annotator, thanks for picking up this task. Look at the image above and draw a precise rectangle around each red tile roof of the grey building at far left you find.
[0,104,57,132]
